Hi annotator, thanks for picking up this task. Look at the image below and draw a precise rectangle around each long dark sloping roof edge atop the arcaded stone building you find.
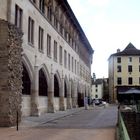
[58,0,94,54]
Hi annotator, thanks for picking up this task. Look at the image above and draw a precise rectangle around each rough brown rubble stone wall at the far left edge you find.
[0,20,22,126]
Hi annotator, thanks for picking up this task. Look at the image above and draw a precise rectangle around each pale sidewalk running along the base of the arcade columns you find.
[19,107,85,128]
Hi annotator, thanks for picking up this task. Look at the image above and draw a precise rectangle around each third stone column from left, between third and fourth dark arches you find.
[59,74,66,111]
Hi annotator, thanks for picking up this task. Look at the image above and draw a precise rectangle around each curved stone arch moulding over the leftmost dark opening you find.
[22,54,34,82]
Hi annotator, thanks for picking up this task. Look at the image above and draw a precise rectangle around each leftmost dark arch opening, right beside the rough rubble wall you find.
[22,64,31,95]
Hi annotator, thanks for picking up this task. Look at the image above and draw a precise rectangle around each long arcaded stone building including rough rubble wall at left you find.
[0,0,93,126]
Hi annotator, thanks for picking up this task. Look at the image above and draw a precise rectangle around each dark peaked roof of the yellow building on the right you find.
[110,43,140,57]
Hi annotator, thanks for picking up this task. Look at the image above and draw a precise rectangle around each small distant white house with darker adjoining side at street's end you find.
[91,78,108,100]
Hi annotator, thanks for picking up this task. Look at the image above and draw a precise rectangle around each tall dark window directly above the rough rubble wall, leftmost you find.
[15,5,23,29]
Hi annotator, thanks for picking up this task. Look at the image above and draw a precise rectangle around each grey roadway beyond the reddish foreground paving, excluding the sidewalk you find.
[41,106,117,129]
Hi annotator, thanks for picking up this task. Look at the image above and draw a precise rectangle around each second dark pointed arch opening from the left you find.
[39,69,48,96]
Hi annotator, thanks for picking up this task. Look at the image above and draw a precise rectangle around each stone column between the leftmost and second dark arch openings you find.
[31,66,40,116]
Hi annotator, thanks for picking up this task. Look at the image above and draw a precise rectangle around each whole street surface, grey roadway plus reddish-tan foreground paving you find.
[0,106,117,140]
